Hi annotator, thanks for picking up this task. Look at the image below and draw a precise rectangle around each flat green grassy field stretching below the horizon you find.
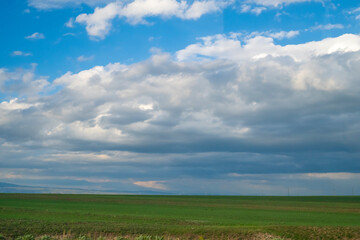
[0,194,360,239]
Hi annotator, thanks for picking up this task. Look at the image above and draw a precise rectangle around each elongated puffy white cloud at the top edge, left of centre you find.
[76,0,230,39]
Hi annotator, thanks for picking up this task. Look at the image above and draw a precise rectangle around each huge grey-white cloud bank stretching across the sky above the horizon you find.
[0,34,360,194]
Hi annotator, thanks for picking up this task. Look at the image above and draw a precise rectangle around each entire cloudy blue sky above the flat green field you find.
[0,0,360,195]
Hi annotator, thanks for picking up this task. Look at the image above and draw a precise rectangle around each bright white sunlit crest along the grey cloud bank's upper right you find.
[176,34,360,61]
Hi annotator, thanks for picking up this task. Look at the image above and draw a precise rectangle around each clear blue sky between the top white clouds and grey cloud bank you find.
[0,1,359,78]
